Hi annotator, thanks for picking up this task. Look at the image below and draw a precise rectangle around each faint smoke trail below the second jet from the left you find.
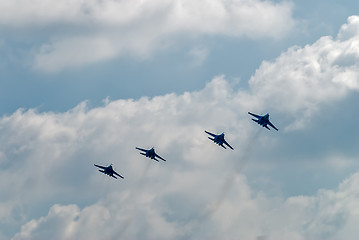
[118,161,152,239]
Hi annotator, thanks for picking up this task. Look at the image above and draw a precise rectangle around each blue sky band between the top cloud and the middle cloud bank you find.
[0,1,357,113]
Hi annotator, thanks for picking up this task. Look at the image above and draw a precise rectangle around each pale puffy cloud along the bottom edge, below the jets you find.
[13,173,359,240]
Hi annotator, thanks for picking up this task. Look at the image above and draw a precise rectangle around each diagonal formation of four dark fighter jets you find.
[94,112,278,179]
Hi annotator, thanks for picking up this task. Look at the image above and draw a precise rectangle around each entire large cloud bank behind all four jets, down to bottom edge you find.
[0,17,359,239]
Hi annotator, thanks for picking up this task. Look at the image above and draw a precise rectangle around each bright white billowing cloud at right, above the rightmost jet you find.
[249,16,359,128]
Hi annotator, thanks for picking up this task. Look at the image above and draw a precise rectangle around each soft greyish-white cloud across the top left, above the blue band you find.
[0,0,294,72]
